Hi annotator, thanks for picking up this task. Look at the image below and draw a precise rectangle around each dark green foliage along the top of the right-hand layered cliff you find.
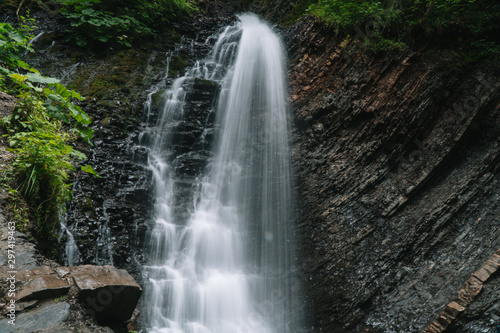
[307,0,500,60]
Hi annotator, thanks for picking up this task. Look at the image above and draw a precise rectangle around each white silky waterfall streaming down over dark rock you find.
[142,14,299,333]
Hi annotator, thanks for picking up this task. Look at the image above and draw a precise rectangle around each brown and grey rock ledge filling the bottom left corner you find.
[0,265,142,333]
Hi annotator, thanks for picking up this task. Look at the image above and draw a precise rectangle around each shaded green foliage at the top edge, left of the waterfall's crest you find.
[57,0,198,47]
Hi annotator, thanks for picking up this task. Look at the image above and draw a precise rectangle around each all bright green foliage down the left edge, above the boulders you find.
[0,17,95,240]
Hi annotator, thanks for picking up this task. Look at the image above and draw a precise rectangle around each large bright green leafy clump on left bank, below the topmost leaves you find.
[3,74,93,239]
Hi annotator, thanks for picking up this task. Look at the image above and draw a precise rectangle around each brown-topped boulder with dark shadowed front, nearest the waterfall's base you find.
[56,265,142,324]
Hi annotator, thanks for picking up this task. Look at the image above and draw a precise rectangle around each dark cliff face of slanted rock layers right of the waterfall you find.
[285,14,500,333]
